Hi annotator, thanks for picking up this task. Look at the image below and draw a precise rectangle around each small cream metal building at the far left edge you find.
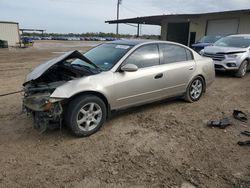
[0,21,20,46]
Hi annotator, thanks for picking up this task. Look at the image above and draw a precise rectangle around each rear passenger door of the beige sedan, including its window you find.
[159,43,196,96]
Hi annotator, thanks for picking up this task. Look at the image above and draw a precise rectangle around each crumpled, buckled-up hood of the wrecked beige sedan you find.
[25,50,96,83]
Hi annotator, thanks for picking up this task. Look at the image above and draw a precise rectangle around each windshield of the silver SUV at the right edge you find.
[214,36,250,48]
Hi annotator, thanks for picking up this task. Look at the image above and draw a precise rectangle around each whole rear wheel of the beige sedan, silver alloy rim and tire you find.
[184,77,205,102]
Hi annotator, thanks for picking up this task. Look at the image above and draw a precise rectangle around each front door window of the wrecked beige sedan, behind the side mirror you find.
[125,44,160,68]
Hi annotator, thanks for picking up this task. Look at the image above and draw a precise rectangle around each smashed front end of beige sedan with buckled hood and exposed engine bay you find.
[23,51,100,132]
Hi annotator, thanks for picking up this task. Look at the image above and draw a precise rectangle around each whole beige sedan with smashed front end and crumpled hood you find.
[23,40,215,137]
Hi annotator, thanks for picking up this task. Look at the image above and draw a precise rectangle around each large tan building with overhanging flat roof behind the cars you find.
[106,9,250,45]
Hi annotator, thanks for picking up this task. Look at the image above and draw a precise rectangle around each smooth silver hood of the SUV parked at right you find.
[204,46,247,54]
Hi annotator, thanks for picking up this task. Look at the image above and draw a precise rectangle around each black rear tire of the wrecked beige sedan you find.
[184,76,205,103]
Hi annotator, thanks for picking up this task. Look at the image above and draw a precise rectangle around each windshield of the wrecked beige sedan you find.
[84,43,132,71]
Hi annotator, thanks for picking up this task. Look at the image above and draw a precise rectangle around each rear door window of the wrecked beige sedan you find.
[159,44,193,64]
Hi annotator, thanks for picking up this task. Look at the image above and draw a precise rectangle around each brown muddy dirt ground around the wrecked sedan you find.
[0,41,250,188]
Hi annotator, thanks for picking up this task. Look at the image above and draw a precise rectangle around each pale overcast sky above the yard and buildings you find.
[0,0,250,34]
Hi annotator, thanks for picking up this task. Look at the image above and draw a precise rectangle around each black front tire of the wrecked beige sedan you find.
[64,95,107,137]
